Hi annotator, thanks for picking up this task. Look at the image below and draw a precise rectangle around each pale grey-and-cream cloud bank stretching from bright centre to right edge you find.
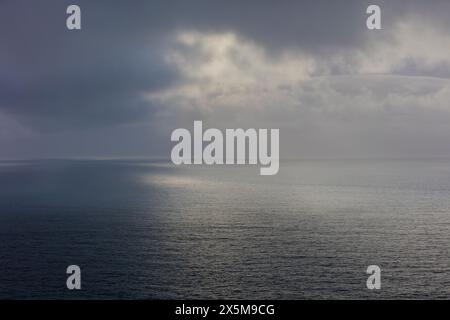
[147,22,450,156]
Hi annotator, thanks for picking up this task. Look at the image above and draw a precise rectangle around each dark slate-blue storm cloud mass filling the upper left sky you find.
[0,1,176,130]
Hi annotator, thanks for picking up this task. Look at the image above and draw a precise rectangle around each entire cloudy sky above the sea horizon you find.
[0,0,450,159]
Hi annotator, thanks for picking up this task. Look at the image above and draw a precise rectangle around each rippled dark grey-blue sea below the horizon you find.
[0,160,450,299]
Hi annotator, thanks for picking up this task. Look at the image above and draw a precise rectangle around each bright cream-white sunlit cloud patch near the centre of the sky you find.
[148,32,316,118]
